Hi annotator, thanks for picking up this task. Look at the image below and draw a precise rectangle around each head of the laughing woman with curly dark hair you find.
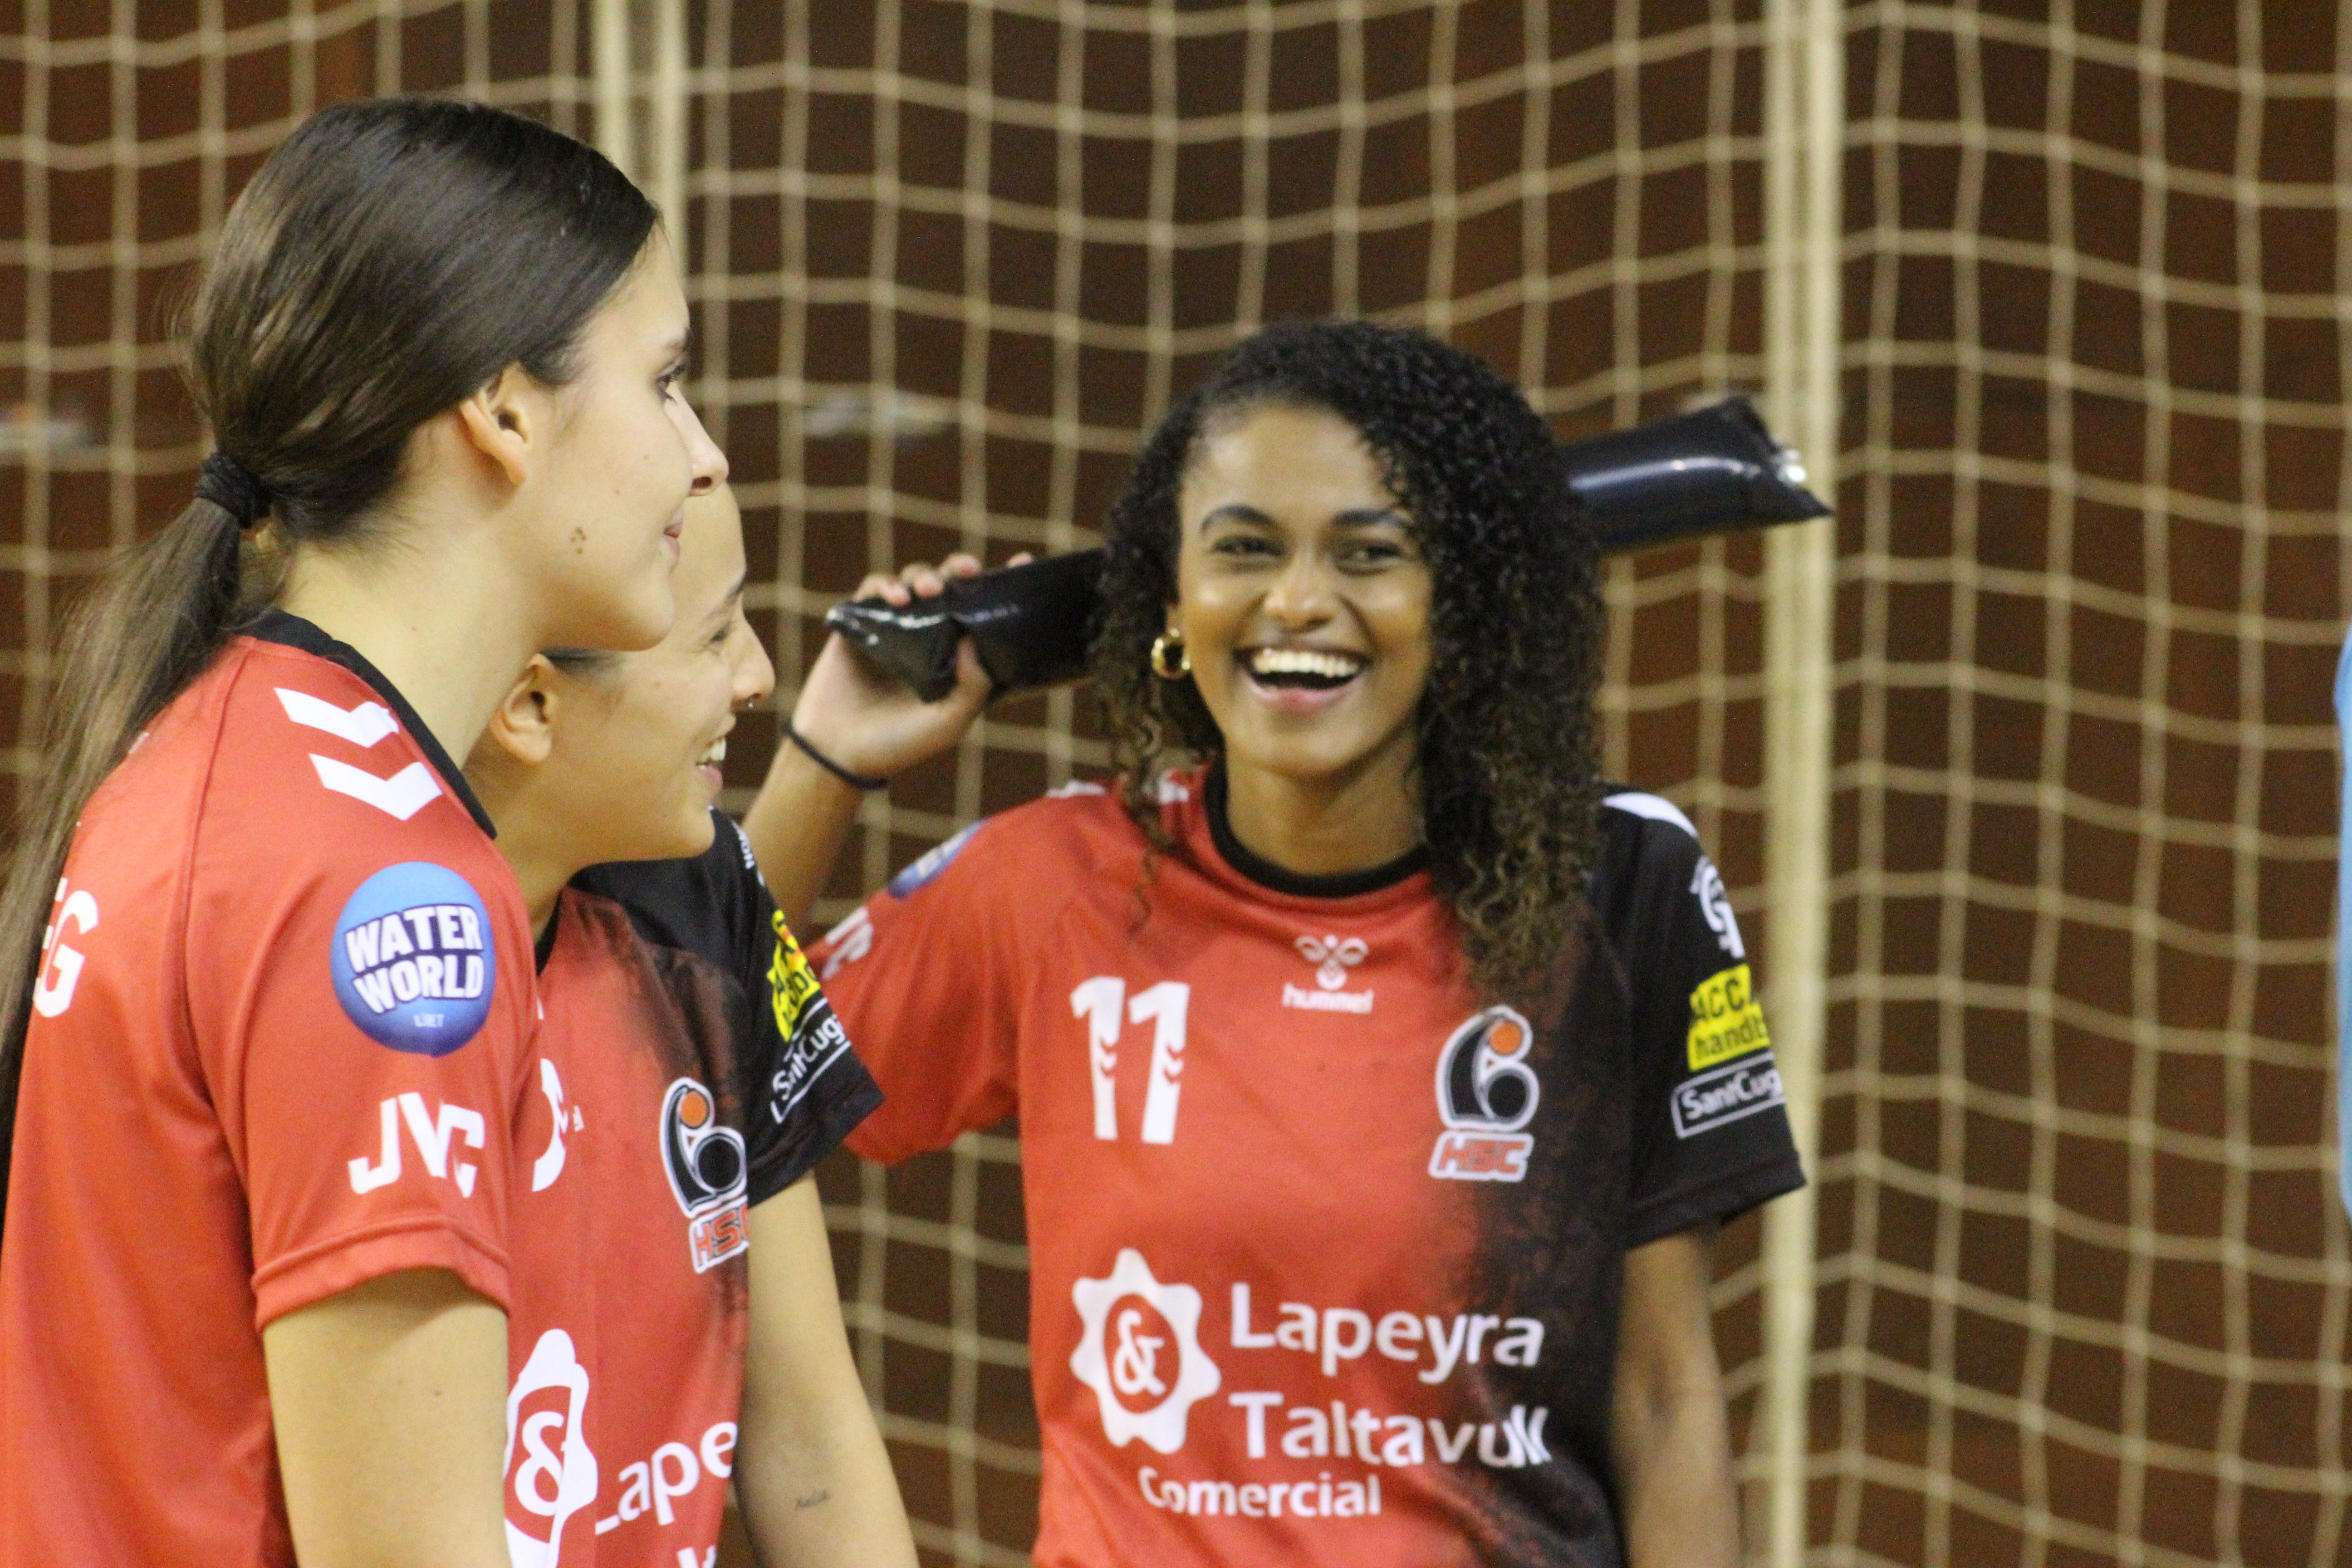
[1094,324,1602,987]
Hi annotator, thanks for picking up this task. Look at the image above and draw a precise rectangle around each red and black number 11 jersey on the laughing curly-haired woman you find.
[811,774,1804,1568]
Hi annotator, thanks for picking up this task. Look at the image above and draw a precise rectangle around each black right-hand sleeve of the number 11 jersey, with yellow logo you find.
[1602,794,1804,1248]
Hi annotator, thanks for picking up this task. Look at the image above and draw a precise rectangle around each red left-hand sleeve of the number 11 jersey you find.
[809,813,1025,1161]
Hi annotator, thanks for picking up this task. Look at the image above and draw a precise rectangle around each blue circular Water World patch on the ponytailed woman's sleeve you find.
[329,860,499,1055]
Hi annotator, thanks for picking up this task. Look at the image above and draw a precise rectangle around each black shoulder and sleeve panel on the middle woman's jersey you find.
[572,811,882,1204]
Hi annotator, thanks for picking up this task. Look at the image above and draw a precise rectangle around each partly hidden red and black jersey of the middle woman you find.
[506,813,880,1568]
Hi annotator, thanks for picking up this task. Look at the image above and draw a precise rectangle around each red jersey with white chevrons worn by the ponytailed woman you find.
[0,613,534,1568]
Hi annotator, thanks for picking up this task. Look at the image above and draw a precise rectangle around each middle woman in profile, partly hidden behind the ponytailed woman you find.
[466,487,912,1568]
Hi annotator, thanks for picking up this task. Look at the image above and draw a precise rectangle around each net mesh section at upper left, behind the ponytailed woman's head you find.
[0,0,593,799]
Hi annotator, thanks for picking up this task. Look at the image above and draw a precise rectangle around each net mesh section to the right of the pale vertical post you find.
[1813,2,2352,1568]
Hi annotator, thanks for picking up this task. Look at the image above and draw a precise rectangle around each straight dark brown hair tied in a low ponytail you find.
[0,99,656,1232]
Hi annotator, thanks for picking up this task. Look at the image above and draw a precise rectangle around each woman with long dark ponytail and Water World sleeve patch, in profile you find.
[0,101,725,1568]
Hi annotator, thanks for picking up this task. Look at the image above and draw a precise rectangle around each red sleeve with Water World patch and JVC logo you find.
[183,823,534,1326]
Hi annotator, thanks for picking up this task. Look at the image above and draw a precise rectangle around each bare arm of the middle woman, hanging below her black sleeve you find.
[734,1178,915,1568]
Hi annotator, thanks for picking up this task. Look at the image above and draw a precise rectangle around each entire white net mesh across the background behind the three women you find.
[0,0,2352,1566]
